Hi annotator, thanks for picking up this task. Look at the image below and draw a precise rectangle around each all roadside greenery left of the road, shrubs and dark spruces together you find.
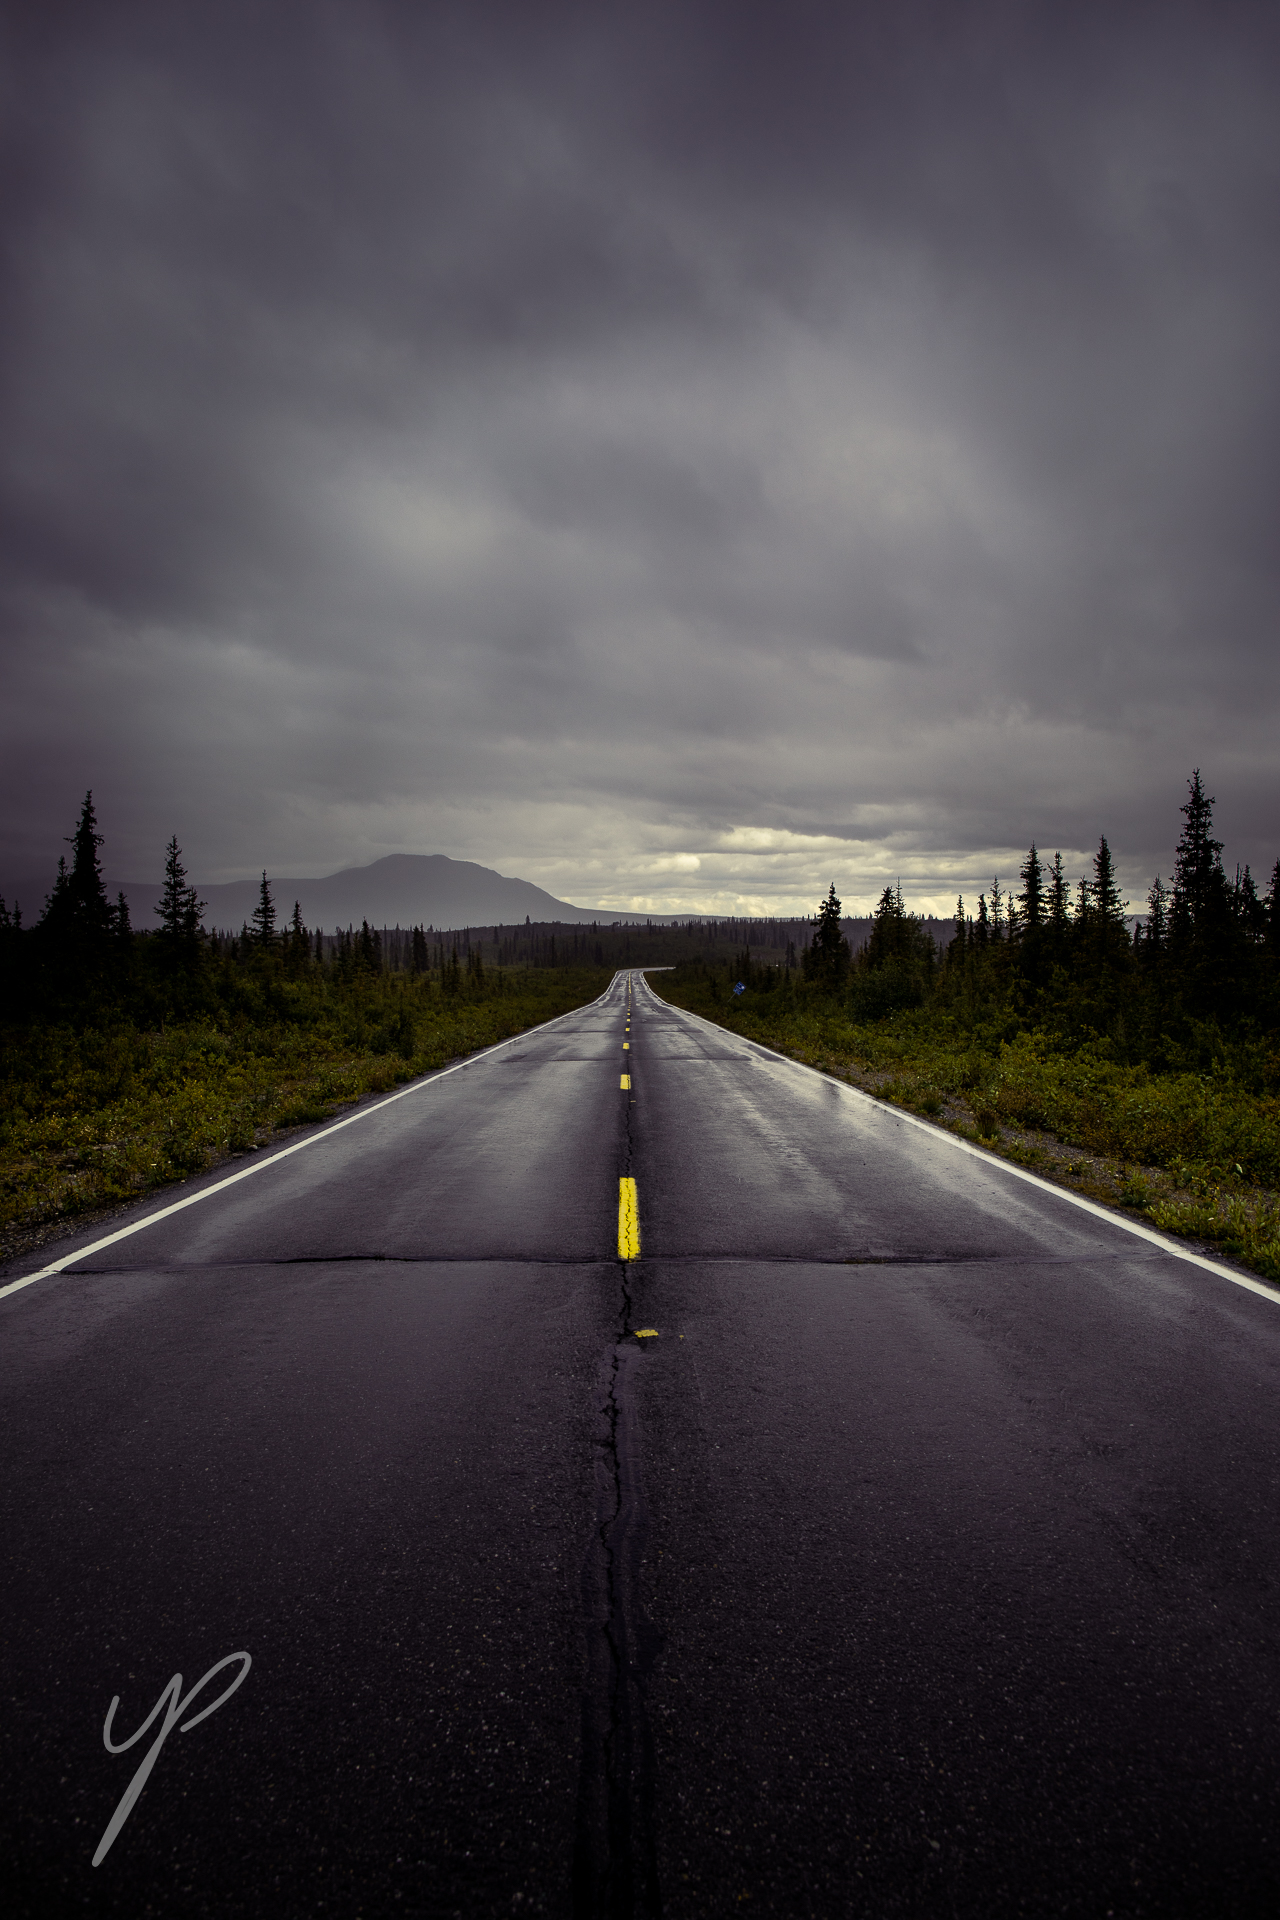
[0,801,610,1252]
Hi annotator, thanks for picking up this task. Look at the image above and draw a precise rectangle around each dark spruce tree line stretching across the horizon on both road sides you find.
[0,770,1280,1064]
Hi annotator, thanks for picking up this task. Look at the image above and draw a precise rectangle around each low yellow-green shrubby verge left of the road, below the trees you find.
[0,968,610,1258]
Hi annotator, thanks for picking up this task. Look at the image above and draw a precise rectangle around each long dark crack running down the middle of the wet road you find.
[574,983,662,1920]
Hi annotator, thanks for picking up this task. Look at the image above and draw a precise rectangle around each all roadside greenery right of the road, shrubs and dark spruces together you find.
[651,774,1280,1281]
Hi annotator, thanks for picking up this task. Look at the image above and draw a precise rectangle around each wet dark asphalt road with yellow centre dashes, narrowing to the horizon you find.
[0,975,1280,1920]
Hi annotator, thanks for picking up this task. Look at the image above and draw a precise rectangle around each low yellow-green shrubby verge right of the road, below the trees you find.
[651,972,1280,1283]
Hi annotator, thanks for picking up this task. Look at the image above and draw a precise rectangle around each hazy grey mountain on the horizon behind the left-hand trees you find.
[111,852,618,931]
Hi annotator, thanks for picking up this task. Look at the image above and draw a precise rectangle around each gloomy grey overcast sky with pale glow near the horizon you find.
[0,0,1280,912]
